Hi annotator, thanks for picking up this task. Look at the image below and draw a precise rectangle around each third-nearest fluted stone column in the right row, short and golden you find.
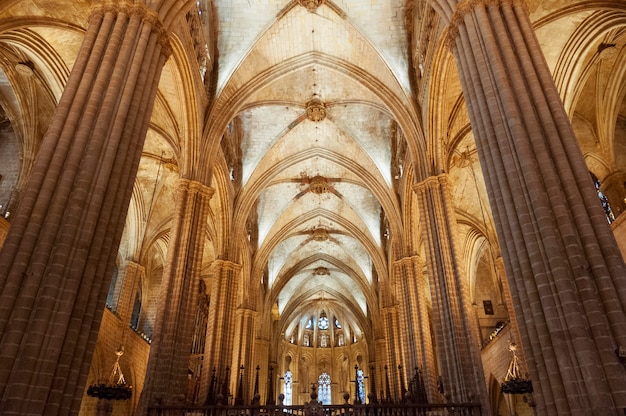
[394,256,437,402]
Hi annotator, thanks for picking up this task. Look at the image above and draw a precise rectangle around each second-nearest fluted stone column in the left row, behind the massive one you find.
[138,179,213,414]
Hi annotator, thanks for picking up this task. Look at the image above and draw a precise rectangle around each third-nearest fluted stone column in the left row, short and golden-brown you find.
[202,260,241,401]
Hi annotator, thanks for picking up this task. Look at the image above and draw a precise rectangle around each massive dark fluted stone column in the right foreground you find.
[433,0,626,415]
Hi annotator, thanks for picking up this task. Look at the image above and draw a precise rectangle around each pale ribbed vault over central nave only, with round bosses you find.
[214,0,417,340]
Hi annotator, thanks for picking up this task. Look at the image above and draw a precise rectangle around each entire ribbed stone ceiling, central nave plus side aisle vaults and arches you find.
[0,0,626,348]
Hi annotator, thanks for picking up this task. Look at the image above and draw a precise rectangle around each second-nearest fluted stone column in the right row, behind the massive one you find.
[414,175,489,414]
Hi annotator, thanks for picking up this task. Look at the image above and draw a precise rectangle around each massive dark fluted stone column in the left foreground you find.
[0,2,183,415]
